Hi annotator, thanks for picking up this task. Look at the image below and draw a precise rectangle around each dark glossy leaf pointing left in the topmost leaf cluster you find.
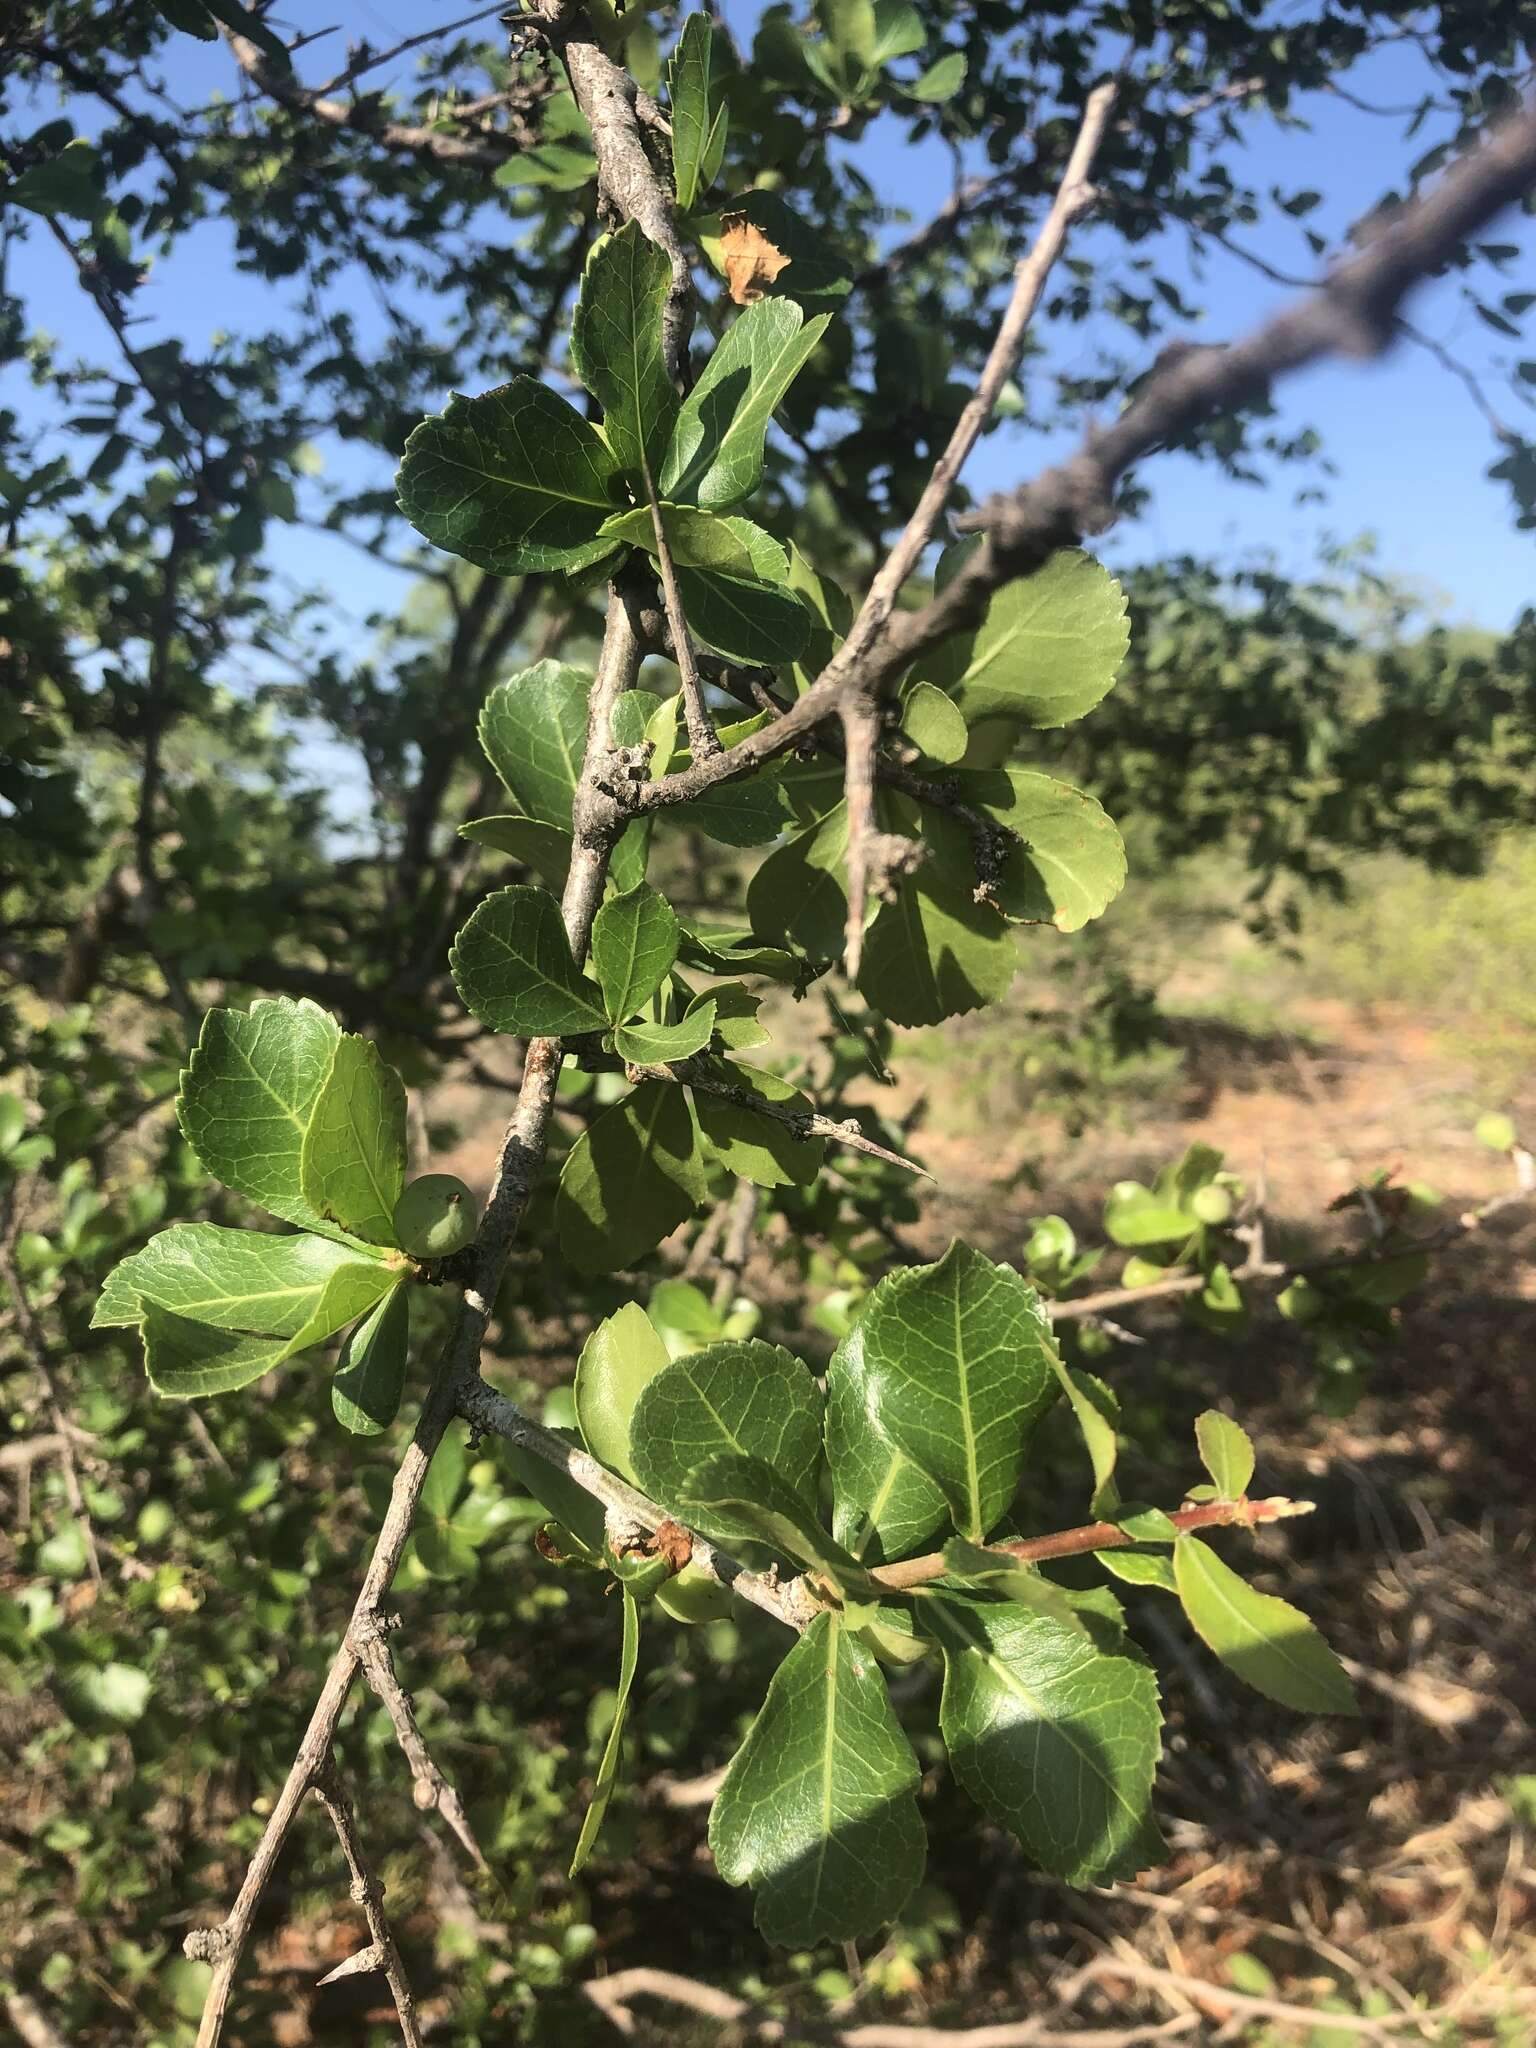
[395,377,618,575]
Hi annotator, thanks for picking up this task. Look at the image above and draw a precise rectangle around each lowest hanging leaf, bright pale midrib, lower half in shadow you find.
[709,1614,926,1948]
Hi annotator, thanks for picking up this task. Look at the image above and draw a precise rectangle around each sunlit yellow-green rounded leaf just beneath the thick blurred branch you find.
[918,541,1130,727]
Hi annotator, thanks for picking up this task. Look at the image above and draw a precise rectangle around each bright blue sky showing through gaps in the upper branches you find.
[12,0,1536,629]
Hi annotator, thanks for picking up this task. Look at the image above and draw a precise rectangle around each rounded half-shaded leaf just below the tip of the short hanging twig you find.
[860,868,1018,1024]
